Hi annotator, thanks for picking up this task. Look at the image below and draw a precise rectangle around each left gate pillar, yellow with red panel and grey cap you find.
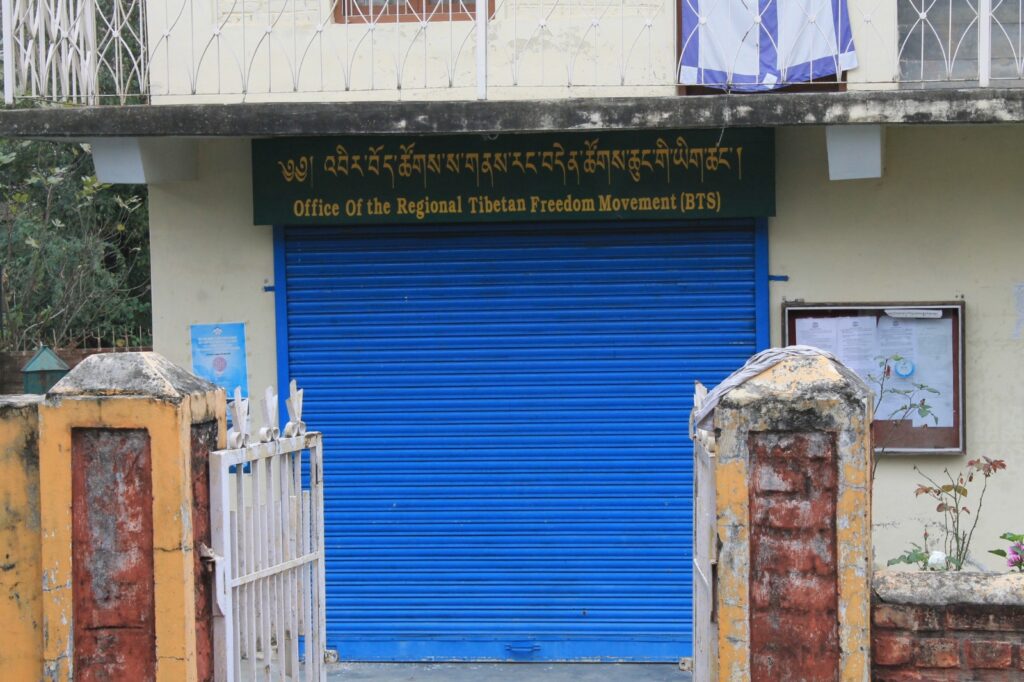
[39,353,224,682]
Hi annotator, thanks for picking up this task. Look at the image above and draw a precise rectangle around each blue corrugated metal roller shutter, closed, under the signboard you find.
[279,223,756,660]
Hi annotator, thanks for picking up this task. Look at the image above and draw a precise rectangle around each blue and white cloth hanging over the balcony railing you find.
[679,0,857,91]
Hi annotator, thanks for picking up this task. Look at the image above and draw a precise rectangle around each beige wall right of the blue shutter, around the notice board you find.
[770,127,1024,567]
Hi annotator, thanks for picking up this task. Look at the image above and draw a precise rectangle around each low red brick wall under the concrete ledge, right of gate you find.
[871,573,1024,682]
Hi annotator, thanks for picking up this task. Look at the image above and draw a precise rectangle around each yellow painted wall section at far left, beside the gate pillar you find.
[0,395,43,680]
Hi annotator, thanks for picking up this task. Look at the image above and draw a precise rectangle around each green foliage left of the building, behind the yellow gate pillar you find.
[0,140,151,350]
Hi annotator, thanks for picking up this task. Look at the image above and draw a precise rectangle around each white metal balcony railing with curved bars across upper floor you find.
[2,0,1024,103]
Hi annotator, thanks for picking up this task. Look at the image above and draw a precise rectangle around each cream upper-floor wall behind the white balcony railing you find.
[146,0,897,104]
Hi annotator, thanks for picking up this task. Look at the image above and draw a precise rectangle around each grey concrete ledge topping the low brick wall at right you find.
[871,570,1024,606]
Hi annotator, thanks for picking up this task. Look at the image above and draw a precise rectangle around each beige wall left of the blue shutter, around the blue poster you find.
[150,140,278,403]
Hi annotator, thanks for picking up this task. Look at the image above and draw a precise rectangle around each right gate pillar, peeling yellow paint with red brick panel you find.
[698,355,871,682]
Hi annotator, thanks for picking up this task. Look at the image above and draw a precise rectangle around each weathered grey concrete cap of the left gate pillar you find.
[46,352,217,402]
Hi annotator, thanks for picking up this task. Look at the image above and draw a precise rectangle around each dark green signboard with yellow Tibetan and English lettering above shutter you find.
[253,129,775,225]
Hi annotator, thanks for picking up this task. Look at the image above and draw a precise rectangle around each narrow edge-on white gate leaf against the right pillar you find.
[690,382,718,682]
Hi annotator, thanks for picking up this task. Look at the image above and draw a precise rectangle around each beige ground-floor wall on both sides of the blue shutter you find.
[151,127,1024,567]
